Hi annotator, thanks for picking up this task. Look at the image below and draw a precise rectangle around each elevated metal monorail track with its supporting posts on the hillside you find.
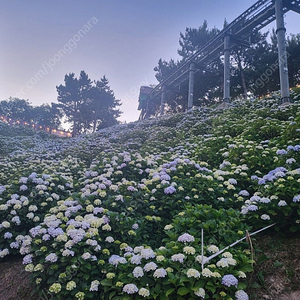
[140,0,300,119]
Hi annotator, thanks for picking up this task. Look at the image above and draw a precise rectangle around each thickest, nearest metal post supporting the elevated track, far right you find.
[275,0,290,104]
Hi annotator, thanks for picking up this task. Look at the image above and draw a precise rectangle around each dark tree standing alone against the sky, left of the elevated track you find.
[56,71,121,135]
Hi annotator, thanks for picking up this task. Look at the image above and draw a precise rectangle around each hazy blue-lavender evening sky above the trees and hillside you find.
[0,0,300,122]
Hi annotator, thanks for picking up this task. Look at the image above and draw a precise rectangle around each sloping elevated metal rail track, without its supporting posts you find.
[141,0,300,117]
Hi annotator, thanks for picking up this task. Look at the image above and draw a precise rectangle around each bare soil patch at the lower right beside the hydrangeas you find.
[248,234,300,300]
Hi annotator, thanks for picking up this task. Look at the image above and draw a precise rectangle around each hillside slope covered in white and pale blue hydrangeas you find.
[0,93,300,300]
